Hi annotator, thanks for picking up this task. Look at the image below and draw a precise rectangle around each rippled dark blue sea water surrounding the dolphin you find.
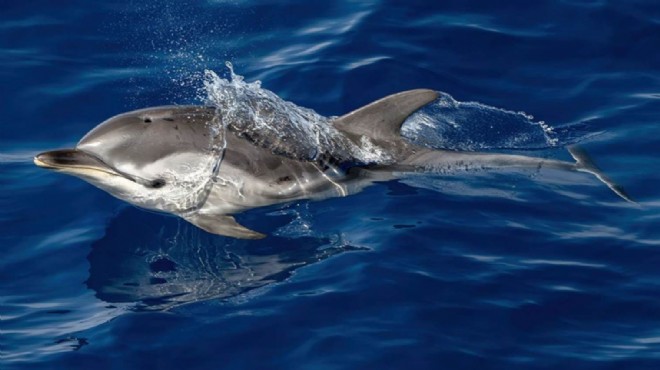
[0,0,660,369]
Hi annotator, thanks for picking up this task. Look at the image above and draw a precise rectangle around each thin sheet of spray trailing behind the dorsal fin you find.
[401,93,560,151]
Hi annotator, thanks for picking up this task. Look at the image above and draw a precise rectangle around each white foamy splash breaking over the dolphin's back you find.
[204,62,390,163]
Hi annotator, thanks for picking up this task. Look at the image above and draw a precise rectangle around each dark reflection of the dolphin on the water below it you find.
[87,207,357,310]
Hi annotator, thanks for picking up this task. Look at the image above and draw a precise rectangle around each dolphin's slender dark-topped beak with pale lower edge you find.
[34,149,119,175]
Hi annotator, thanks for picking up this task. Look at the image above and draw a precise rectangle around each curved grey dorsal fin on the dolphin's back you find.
[333,89,438,140]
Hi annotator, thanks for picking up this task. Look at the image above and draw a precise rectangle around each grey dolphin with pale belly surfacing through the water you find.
[34,89,632,239]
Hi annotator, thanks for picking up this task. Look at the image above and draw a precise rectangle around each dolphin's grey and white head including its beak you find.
[34,106,223,213]
